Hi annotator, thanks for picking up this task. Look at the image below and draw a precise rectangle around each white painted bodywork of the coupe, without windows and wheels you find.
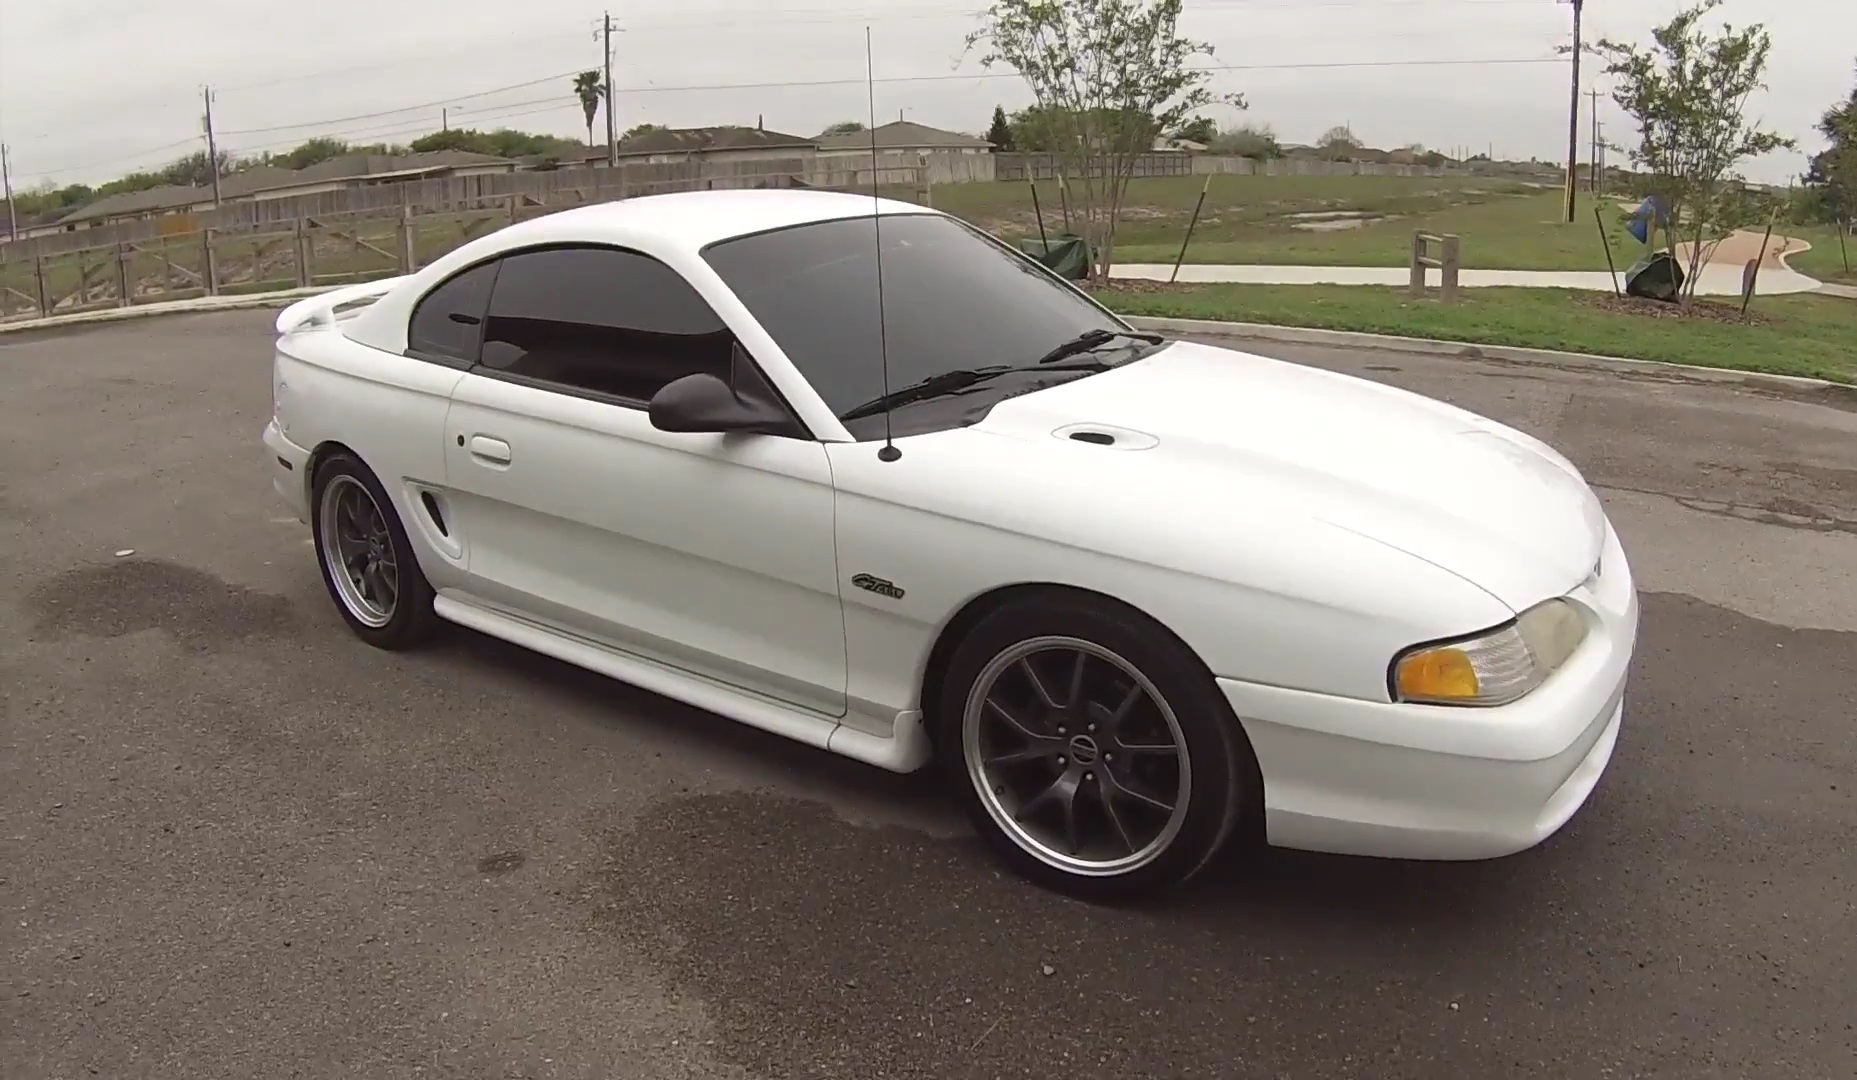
[264,191,1638,859]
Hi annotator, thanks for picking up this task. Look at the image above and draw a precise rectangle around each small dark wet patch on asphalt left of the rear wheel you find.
[26,559,293,649]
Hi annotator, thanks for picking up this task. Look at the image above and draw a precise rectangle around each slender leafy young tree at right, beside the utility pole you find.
[1595,0,1796,302]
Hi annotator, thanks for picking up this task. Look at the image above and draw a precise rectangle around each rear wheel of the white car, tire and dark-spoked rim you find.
[310,453,435,649]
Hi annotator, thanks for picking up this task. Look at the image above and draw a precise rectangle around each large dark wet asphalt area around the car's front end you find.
[589,596,1857,1080]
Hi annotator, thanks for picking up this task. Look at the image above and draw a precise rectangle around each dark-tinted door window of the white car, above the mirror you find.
[481,247,734,405]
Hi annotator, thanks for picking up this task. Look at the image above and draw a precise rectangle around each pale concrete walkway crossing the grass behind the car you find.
[1109,264,1818,297]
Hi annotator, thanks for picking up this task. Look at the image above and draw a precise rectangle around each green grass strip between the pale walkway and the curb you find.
[1097,284,1857,382]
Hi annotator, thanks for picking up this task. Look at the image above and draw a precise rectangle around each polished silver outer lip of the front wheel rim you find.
[960,635,1192,878]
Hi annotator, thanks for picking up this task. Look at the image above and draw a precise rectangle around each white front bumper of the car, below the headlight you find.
[1220,529,1638,859]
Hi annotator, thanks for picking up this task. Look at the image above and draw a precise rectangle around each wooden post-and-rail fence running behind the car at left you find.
[0,167,929,321]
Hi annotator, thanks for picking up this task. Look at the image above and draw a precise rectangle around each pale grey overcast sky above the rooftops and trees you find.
[0,0,1857,187]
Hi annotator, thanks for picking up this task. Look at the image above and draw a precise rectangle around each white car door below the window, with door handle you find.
[446,373,845,716]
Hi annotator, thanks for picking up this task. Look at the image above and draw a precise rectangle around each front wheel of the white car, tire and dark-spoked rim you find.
[940,598,1252,900]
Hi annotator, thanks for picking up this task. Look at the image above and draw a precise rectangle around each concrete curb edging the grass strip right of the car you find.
[1123,315,1857,393]
